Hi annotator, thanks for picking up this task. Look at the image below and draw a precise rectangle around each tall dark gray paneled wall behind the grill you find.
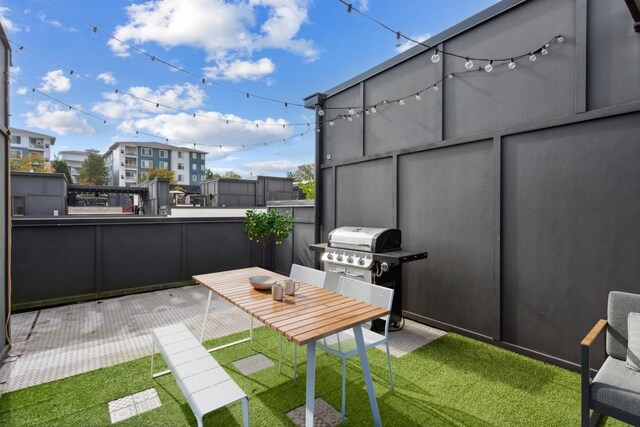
[317,0,640,365]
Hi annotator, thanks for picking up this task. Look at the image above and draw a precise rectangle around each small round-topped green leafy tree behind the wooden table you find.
[244,209,293,266]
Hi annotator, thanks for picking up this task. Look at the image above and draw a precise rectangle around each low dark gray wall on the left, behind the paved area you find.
[12,217,261,309]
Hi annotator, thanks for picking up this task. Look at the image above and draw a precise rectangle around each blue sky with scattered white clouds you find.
[0,0,496,177]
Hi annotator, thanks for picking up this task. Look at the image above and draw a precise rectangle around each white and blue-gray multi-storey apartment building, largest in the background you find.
[103,142,207,187]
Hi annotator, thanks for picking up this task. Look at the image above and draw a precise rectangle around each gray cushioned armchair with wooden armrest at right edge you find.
[581,292,640,427]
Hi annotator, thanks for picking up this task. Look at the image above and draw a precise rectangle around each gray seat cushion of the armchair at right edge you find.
[591,357,640,416]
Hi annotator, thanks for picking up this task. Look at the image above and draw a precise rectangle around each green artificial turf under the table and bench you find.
[0,328,622,426]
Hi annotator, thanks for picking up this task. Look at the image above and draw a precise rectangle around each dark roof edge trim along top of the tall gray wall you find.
[305,0,530,102]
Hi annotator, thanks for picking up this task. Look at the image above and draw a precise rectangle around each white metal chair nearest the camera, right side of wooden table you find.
[317,276,394,423]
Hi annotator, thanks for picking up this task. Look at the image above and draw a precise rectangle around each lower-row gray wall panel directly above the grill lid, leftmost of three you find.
[336,158,395,232]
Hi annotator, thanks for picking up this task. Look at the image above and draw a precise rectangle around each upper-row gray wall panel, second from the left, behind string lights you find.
[364,55,441,154]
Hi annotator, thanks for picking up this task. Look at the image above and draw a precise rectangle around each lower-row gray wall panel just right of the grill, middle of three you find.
[398,141,494,335]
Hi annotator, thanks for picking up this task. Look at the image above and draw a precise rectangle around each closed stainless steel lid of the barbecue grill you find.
[329,227,402,252]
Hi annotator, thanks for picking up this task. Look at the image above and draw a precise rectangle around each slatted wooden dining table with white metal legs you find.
[193,267,389,427]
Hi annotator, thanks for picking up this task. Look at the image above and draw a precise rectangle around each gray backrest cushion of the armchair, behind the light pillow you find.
[606,291,640,361]
